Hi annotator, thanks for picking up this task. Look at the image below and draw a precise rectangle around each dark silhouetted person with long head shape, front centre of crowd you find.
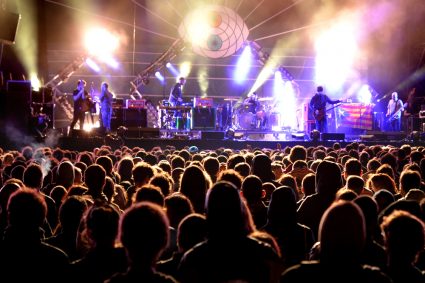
[178,181,280,282]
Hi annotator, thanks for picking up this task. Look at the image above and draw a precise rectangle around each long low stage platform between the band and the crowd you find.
[0,124,425,151]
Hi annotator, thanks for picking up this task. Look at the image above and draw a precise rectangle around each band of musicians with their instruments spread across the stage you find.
[44,77,422,138]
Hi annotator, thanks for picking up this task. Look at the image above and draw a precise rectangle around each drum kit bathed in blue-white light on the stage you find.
[227,97,280,130]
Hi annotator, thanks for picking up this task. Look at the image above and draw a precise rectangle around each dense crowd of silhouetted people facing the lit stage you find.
[0,142,425,283]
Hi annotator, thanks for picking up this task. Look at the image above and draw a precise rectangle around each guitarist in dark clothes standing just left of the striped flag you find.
[310,86,341,133]
